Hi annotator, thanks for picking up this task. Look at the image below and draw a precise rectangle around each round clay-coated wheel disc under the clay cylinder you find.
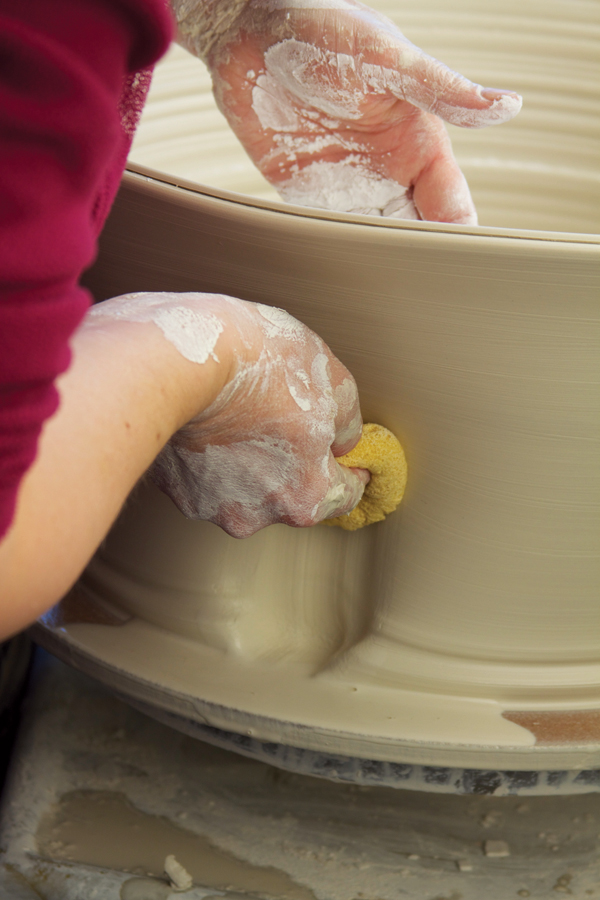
[34,512,600,794]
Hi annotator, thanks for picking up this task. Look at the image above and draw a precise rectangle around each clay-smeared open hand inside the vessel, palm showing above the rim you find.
[172,0,521,224]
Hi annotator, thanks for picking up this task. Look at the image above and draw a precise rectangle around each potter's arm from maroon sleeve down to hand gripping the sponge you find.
[0,0,366,639]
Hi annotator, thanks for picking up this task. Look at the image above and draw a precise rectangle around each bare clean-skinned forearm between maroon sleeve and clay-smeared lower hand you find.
[0,319,228,639]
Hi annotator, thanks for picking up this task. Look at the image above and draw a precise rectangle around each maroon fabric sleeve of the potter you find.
[0,0,171,536]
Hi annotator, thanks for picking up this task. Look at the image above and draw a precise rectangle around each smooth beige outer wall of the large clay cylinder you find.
[88,173,600,696]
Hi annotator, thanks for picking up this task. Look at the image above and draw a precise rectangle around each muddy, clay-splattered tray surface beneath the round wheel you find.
[0,663,600,900]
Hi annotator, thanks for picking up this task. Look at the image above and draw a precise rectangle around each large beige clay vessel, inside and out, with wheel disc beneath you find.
[35,0,600,793]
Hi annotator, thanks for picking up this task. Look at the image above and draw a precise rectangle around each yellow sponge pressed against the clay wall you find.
[323,425,407,531]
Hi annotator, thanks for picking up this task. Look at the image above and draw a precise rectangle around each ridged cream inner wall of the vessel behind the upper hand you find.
[130,0,600,233]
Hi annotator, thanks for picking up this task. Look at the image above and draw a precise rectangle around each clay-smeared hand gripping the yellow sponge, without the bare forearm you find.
[92,293,369,537]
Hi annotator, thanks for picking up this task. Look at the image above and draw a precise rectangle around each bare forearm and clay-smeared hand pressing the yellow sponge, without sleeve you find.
[0,294,365,639]
